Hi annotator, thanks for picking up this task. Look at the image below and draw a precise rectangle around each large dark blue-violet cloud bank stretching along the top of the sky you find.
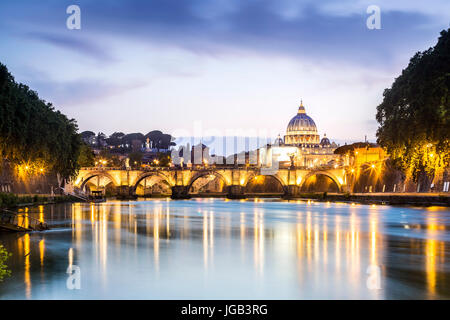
[52,0,440,65]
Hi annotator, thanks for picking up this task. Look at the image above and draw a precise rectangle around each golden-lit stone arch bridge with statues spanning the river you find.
[74,166,348,199]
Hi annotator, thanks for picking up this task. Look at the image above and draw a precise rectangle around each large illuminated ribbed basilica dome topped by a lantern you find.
[284,102,319,147]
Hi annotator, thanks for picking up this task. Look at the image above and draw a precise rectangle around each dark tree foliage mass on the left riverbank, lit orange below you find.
[0,64,81,178]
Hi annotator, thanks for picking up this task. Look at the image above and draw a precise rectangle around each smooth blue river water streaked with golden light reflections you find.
[0,199,450,299]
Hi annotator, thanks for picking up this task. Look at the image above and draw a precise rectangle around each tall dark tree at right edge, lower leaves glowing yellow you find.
[376,29,450,185]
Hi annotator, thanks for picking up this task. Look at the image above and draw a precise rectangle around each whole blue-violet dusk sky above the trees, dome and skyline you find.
[0,0,450,141]
